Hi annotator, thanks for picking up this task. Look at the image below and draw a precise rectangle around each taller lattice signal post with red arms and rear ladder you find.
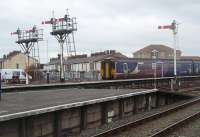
[42,10,77,82]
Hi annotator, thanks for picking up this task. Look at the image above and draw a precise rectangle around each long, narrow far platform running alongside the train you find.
[2,76,200,92]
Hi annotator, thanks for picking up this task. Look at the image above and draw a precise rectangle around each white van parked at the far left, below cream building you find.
[0,69,26,83]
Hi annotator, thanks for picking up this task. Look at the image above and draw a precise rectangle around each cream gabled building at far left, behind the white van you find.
[0,51,38,69]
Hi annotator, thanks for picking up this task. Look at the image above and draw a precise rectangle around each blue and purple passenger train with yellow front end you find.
[100,58,200,80]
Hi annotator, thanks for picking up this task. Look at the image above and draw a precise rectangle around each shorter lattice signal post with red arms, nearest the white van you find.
[11,26,43,84]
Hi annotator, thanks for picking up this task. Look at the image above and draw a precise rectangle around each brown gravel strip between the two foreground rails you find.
[112,102,200,137]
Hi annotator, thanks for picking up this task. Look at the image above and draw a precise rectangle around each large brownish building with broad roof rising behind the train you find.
[133,44,181,59]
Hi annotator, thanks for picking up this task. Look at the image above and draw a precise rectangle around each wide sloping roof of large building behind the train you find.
[134,44,181,54]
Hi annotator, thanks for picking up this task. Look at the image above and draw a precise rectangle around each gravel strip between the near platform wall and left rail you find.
[76,100,195,137]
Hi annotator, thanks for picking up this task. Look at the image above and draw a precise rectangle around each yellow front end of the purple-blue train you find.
[100,60,115,80]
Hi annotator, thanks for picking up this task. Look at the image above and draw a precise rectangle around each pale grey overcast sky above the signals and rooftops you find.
[0,0,200,62]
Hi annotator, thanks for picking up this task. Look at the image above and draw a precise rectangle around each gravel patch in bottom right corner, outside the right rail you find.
[164,118,200,137]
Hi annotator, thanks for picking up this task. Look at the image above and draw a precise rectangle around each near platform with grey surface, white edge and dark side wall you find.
[0,89,191,137]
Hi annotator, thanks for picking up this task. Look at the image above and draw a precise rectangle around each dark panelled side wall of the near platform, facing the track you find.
[0,93,186,137]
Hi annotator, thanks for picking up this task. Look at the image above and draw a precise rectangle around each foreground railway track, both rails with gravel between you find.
[93,98,200,137]
